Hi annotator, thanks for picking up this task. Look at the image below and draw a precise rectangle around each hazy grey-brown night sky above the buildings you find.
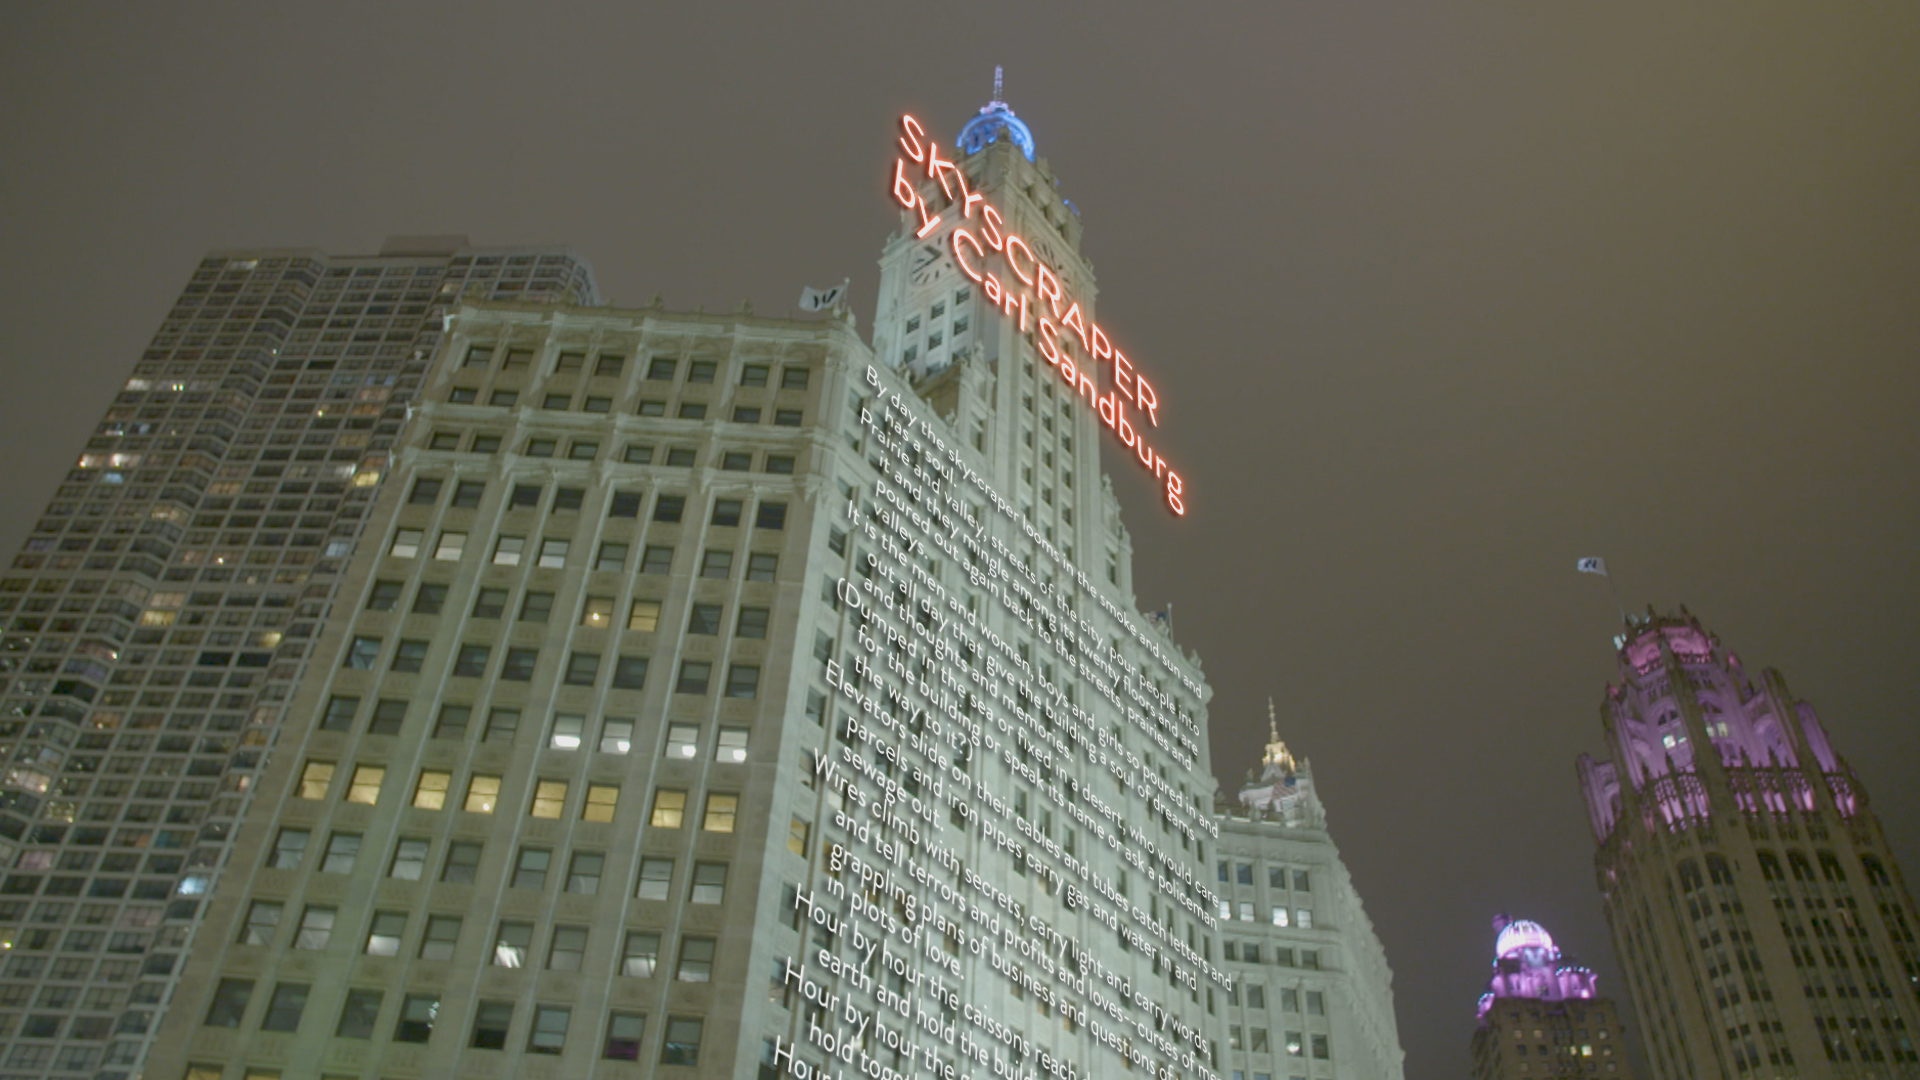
[0,2,1920,1080]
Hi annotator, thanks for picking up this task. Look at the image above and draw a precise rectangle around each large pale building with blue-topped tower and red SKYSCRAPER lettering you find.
[148,92,1244,1080]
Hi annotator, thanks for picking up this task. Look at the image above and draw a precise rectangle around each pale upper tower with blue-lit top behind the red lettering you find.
[874,80,1133,596]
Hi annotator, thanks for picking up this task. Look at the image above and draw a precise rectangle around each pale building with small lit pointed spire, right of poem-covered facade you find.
[1213,703,1405,1080]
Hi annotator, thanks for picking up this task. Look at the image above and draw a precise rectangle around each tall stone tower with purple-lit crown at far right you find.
[1580,609,1920,1080]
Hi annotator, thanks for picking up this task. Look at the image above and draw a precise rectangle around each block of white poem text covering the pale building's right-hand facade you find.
[774,369,1231,1080]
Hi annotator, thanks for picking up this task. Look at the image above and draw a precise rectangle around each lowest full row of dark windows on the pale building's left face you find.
[186,972,712,1053]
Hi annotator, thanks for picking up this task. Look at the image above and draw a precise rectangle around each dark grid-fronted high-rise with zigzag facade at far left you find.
[0,236,597,1080]
